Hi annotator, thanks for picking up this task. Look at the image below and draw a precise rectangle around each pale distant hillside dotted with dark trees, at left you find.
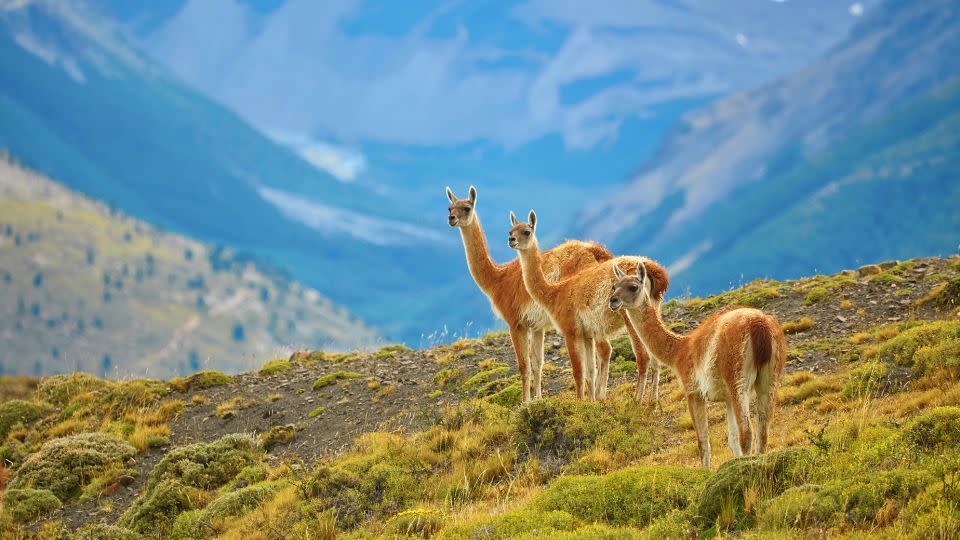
[0,159,376,377]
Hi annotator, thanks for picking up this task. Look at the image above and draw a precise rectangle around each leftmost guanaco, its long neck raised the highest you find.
[447,186,613,401]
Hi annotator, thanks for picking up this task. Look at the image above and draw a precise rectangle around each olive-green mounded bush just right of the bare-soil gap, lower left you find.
[146,433,262,491]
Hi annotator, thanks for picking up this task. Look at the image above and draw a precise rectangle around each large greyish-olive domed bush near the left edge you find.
[10,433,137,502]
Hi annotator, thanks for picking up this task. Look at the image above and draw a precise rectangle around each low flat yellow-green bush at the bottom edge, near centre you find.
[437,509,578,540]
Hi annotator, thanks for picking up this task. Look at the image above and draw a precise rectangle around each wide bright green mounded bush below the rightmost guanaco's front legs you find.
[530,467,709,527]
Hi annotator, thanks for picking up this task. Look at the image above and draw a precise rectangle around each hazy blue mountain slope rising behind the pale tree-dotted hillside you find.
[0,0,462,340]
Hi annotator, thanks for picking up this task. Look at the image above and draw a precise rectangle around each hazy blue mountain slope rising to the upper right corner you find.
[576,0,960,294]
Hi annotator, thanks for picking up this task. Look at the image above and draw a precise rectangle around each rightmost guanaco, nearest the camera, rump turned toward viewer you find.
[610,261,787,467]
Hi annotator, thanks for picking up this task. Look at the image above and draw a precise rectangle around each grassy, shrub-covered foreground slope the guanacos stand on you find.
[0,258,960,539]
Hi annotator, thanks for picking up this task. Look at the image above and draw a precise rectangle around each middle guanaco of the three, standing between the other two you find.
[508,211,667,399]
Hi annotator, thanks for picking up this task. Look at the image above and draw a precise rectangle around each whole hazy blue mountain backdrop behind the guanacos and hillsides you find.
[0,0,960,376]
